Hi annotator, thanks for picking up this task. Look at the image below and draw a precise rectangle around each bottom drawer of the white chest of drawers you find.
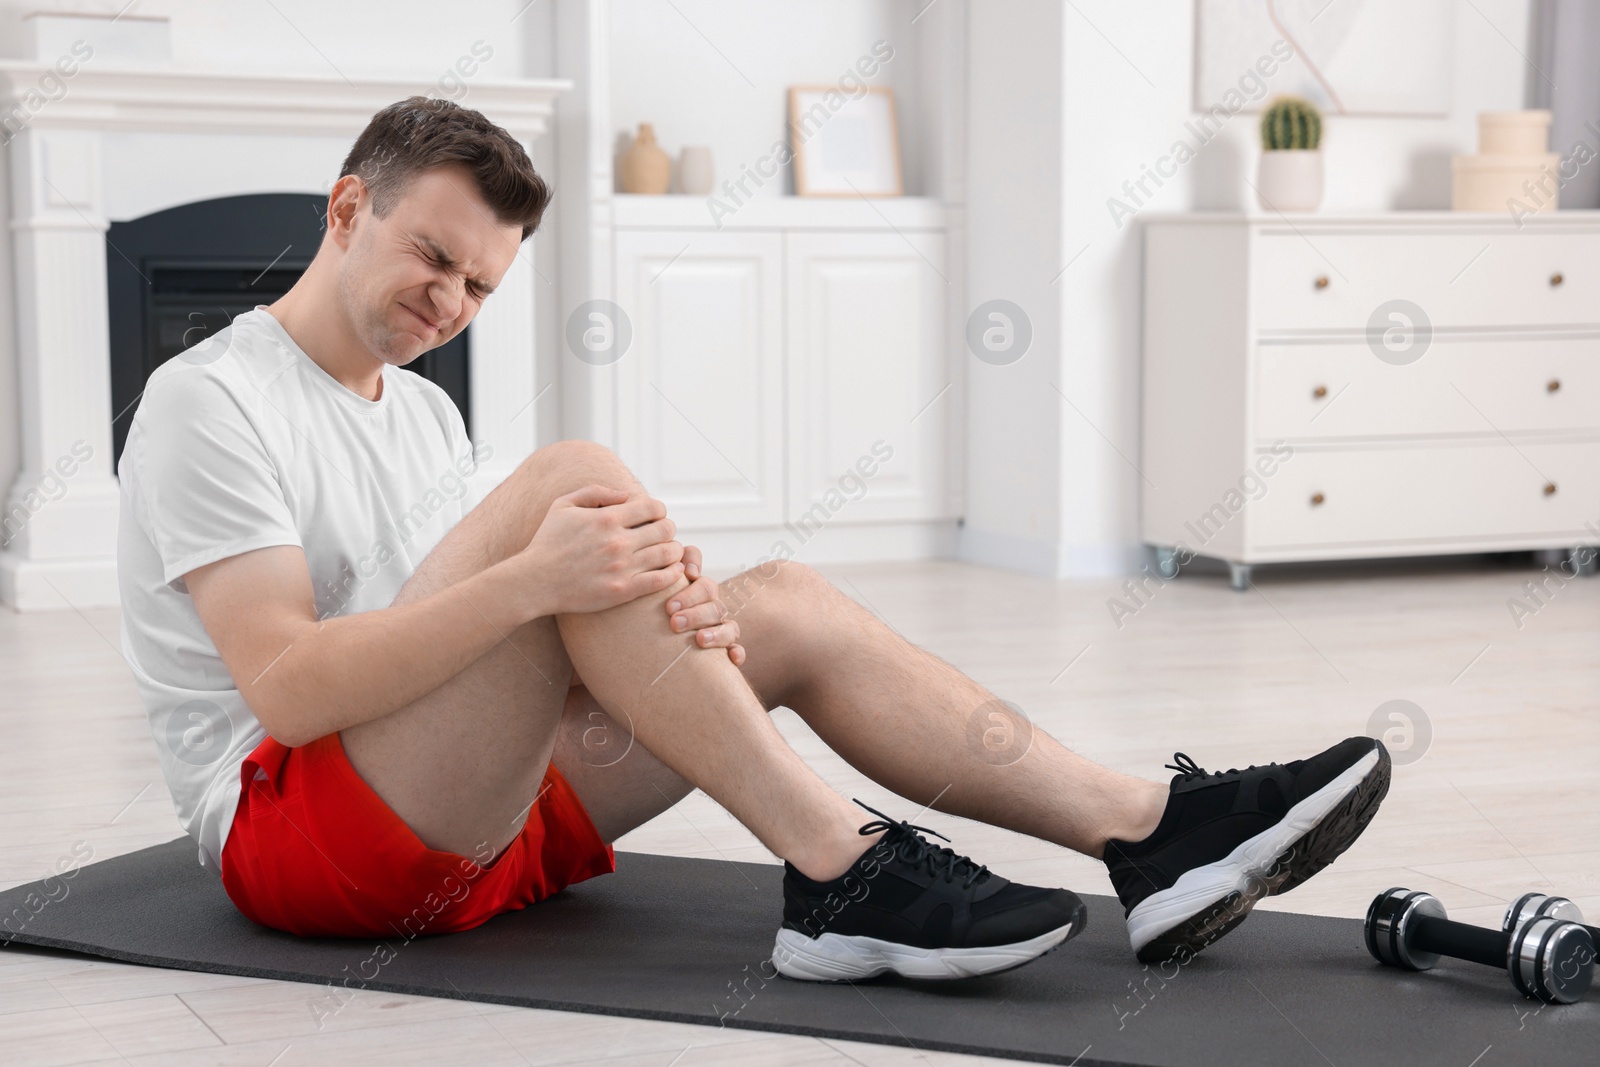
[1246,442,1600,550]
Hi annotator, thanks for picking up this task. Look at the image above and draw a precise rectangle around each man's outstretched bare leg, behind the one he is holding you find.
[573,561,1168,857]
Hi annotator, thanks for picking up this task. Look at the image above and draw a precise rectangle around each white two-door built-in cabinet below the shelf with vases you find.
[608,197,962,560]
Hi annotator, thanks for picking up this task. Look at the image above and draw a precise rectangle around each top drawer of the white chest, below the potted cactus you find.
[1251,231,1600,330]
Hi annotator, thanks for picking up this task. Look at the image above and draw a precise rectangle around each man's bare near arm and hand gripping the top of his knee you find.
[184,486,683,747]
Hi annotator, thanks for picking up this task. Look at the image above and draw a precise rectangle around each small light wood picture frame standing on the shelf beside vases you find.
[789,85,902,197]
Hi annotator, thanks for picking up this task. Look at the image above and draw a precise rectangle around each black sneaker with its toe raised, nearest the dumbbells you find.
[1106,737,1389,963]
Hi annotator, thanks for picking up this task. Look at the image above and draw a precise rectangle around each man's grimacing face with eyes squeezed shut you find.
[336,166,522,366]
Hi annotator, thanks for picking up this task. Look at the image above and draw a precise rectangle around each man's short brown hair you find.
[339,96,550,240]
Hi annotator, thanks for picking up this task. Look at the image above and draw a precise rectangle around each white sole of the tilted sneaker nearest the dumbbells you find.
[1128,750,1378,952]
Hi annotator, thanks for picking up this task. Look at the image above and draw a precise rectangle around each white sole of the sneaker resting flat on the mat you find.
[773,923,1072,982]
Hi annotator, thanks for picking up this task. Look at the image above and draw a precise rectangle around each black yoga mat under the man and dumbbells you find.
[0,838,1600,1067]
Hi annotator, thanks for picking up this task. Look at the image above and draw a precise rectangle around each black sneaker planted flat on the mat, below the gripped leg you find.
[773,800,1088,982]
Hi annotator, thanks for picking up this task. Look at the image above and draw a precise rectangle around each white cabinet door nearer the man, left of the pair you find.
[616,232,784,530]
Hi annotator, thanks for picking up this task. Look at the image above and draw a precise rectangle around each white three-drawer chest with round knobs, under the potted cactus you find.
[1141,211,1600,587]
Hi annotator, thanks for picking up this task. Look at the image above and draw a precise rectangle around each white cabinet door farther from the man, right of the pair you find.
[787,234,957,530]
